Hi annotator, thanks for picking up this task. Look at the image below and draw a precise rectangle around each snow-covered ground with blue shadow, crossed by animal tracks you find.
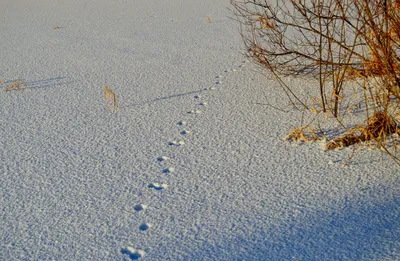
[0,0,400,261]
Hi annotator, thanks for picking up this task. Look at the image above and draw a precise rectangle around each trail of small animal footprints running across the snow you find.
[121,60,248,260]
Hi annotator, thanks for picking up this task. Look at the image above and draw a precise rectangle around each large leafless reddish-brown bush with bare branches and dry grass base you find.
[231,0,400,156]
